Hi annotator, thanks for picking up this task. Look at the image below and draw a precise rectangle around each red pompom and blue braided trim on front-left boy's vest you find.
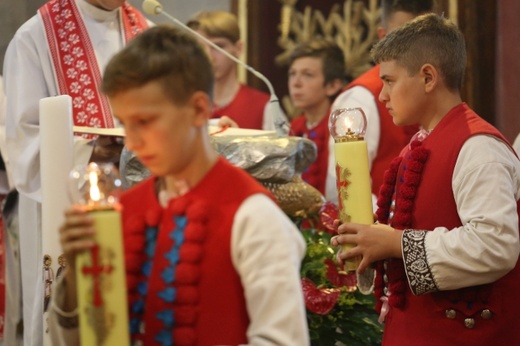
[125,197,207,345]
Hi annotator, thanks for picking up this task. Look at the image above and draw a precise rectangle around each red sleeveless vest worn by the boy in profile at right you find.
[376,104,520,345]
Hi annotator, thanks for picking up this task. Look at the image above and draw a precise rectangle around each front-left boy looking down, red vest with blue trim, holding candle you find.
[49,26,309,346]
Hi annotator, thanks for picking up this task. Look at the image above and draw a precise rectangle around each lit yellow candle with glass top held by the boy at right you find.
[329,108,374,272]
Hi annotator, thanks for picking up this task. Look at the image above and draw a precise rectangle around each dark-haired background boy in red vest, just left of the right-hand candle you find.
[288,40,345,202]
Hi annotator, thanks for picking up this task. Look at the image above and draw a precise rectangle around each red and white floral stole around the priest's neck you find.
[38,0,148,128]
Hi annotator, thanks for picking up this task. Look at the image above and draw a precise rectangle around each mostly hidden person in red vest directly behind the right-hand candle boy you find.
[332,0,435,195]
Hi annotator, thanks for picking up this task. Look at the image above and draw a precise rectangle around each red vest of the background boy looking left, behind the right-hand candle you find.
[291,110,330,195]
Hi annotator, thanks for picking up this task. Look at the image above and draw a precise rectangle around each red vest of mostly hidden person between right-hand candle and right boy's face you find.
[343,65,418,194]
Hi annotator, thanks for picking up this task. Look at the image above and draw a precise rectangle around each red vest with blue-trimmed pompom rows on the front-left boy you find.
[121,158,271,345]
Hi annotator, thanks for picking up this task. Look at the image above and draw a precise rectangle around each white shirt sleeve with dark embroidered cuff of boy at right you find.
[403,135,520,293]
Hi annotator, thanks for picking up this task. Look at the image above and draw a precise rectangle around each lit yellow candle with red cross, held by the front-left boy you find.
[71,163,130,346]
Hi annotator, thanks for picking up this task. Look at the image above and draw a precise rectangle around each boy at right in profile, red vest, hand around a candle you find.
[333,14,520,346]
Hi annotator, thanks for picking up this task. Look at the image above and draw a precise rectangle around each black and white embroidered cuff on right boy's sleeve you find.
[402,229,439,295]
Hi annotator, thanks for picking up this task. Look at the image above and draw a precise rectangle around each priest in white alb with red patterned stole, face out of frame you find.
[3,0,150,345]
